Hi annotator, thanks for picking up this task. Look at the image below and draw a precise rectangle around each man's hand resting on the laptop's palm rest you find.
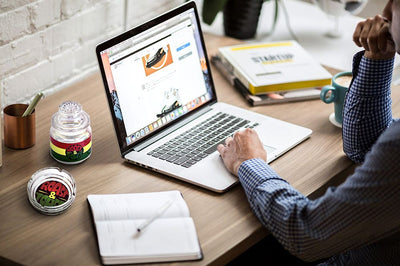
[218,128,267,175]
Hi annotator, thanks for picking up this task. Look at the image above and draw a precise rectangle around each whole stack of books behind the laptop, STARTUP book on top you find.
[211,40,332,105]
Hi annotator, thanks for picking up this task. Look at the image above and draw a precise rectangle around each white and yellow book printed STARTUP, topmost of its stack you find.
[217,40,332,95]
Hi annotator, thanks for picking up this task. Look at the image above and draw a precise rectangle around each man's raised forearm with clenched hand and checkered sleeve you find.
[343,15,395,163]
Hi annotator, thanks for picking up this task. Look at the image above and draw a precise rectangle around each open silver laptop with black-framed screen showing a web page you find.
[96,2,312,192]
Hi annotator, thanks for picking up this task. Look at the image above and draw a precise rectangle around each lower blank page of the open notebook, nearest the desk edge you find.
[96,217,201,263]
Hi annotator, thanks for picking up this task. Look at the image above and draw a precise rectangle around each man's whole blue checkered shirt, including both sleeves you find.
[238,52,400,265]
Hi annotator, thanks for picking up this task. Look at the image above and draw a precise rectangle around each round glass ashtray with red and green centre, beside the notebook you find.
[27,167,76,215]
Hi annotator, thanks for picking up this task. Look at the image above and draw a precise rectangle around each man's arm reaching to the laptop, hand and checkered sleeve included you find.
[218,128,400,261]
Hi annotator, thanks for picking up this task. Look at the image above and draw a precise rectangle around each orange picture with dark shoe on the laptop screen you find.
[142,44,173,76]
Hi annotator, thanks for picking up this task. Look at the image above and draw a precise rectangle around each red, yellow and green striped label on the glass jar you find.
[50,135,92,164]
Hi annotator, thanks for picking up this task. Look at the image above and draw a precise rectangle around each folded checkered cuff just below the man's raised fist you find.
[350,53,394,96]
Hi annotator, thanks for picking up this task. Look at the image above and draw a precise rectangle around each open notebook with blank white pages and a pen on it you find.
[88,191,202,264]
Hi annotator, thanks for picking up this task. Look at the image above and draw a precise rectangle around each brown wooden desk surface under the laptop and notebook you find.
[0,36,398,265]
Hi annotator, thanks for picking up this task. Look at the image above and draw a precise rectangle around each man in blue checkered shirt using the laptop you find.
[218,0,400,265]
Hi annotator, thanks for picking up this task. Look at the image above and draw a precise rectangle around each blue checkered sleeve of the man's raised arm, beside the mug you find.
[343,52,394,163]
